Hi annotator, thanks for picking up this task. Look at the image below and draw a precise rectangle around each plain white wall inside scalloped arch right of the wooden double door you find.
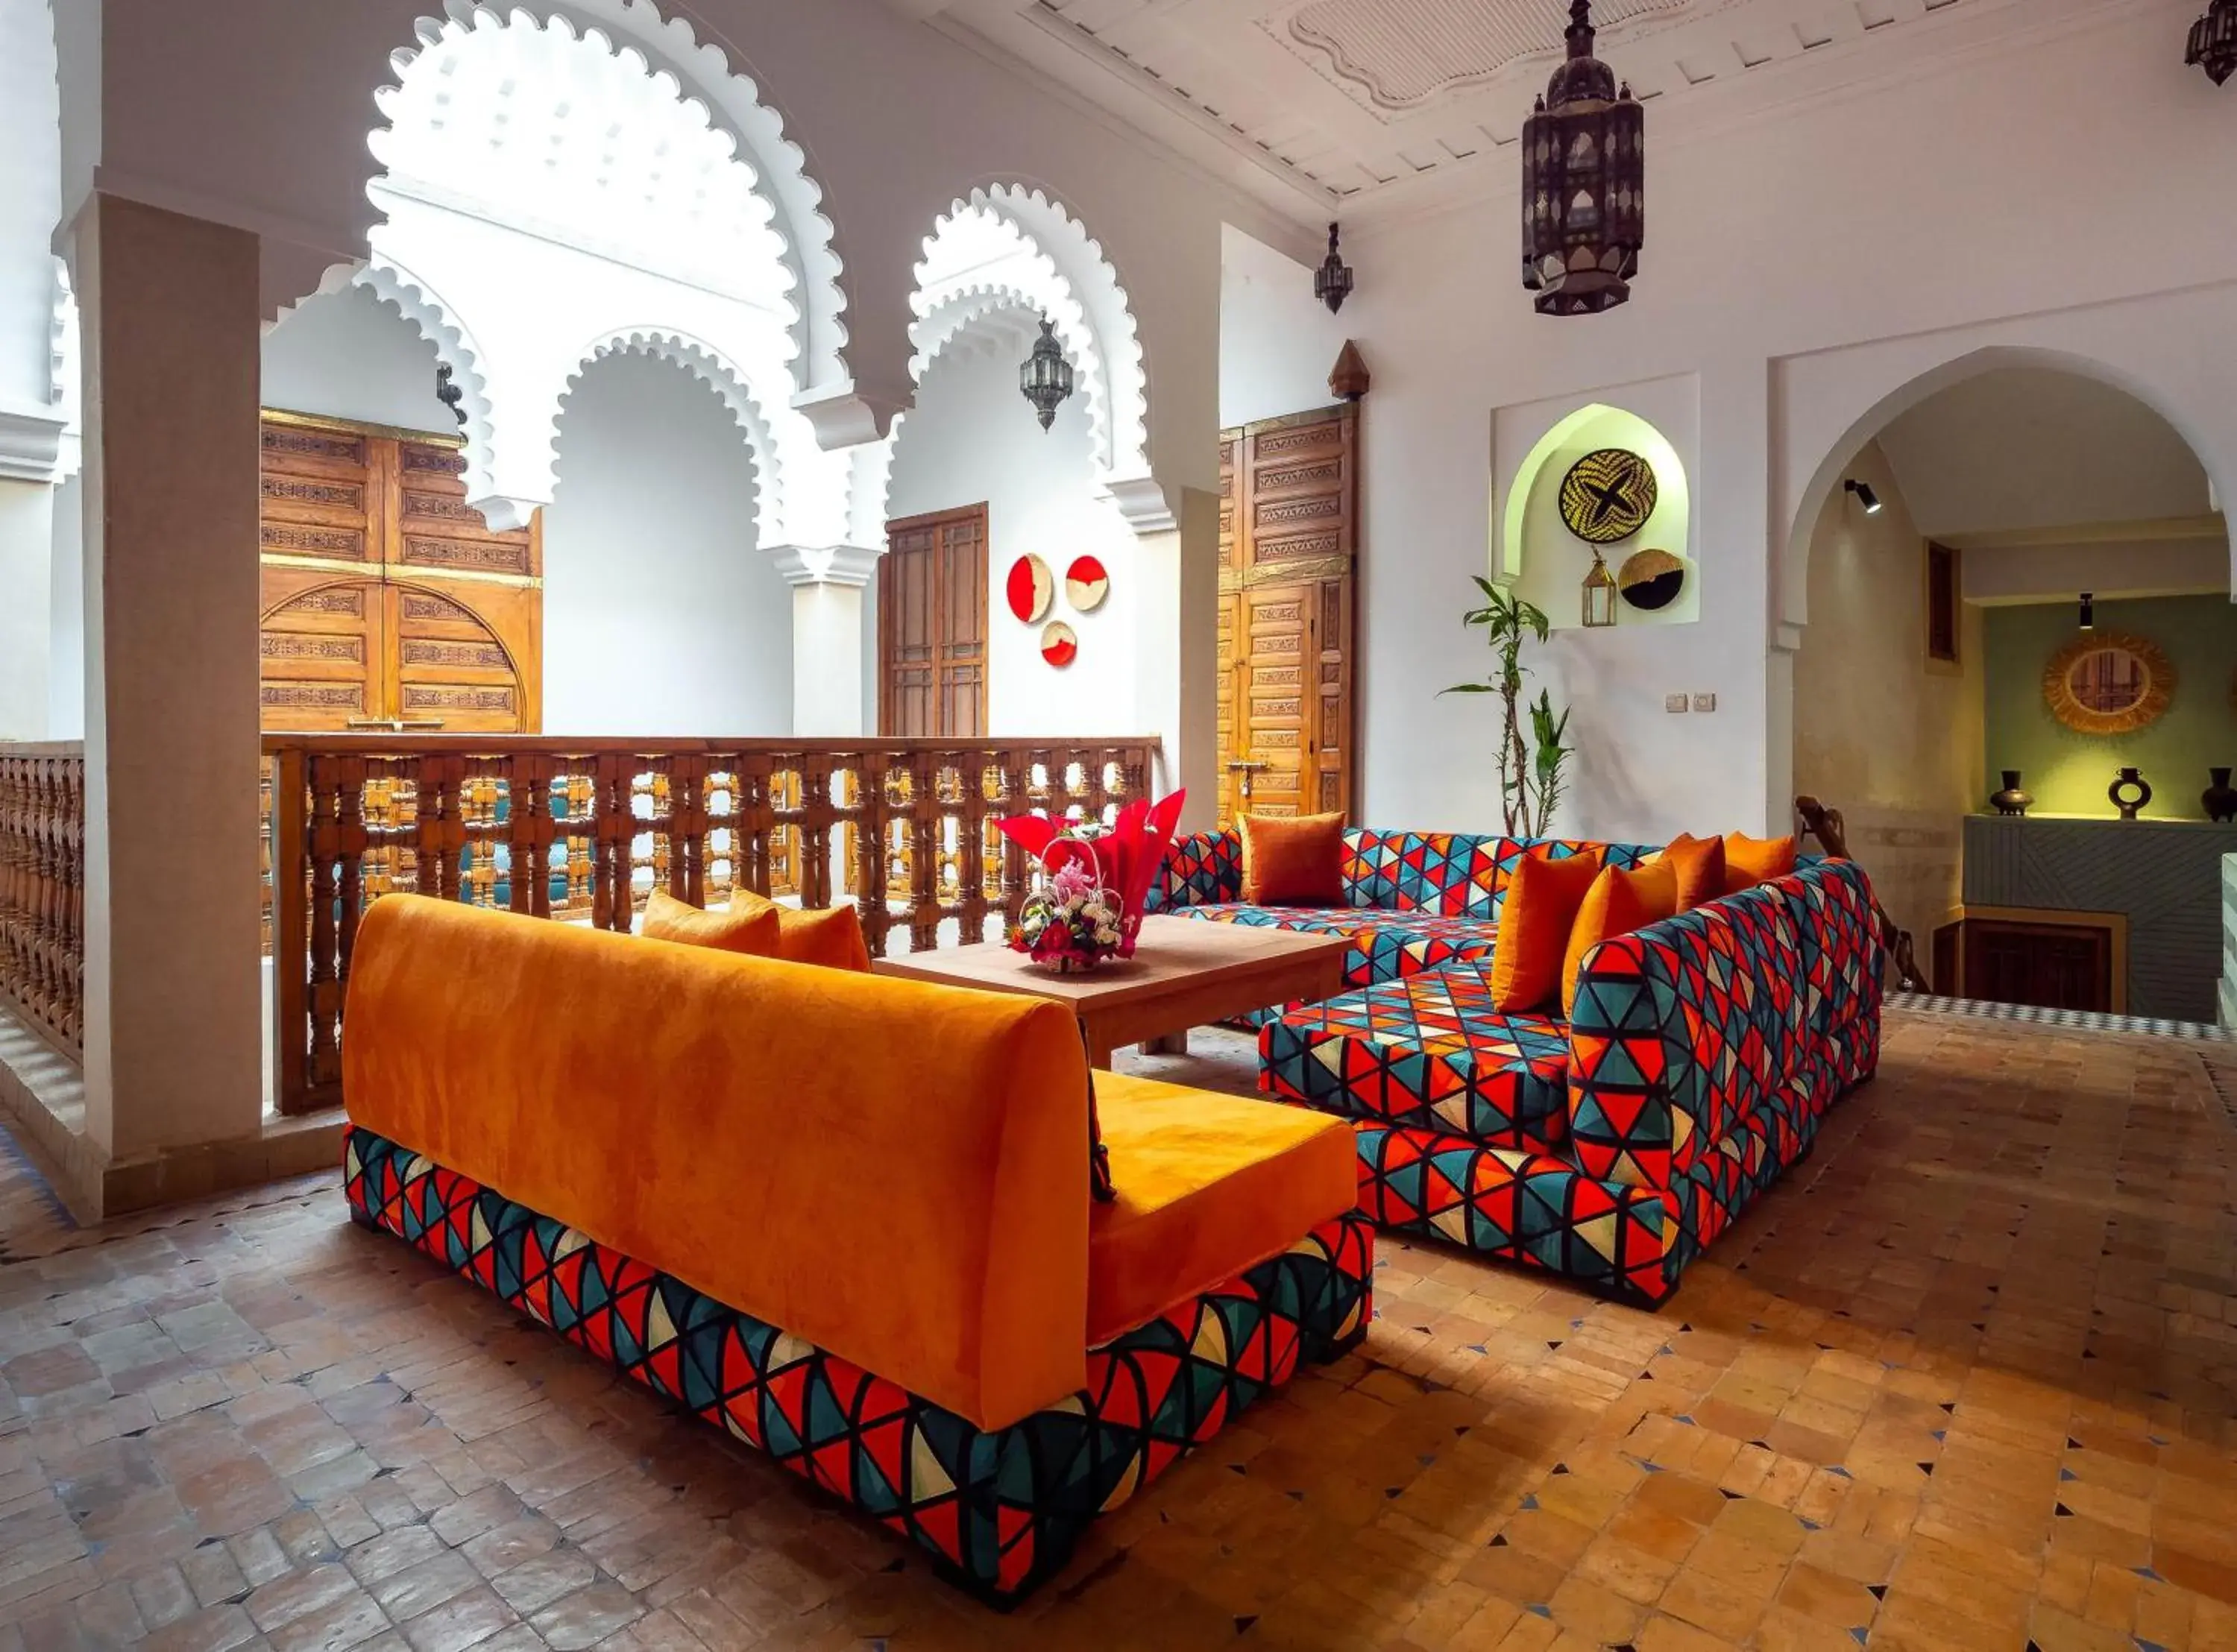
[544,356,787,736]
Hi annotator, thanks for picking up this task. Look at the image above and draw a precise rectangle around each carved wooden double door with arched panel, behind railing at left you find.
[259,414,544,734]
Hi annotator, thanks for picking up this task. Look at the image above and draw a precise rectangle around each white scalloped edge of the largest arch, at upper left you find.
[376,0,848,394]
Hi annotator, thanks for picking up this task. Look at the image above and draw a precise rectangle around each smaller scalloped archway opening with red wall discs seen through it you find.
[863,188,1170,736]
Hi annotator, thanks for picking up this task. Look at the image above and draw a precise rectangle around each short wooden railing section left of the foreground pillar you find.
[0,743,85,1055]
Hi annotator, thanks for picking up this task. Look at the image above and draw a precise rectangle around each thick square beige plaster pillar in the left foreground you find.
[74,195,264,1162]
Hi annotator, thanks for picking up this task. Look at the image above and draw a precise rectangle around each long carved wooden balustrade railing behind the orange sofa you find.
[264,734,1157,1113]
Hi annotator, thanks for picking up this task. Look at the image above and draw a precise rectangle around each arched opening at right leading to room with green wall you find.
[1794,360,2237,1021]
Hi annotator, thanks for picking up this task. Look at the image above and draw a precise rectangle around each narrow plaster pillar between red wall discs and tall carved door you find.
[1125,488,1219,831]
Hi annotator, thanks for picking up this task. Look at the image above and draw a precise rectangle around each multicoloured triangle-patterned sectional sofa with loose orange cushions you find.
[1157,829,1881,1303]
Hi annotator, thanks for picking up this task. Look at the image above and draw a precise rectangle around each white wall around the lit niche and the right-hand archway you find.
[1315,4,2237,838]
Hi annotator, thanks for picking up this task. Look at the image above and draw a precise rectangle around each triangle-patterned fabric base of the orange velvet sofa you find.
[342,1129,1374,1603]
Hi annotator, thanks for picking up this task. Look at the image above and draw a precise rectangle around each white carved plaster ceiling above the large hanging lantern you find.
[888,0,2076,224]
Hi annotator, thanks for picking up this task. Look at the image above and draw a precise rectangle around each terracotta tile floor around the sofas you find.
[0,1015,2237,1652]
